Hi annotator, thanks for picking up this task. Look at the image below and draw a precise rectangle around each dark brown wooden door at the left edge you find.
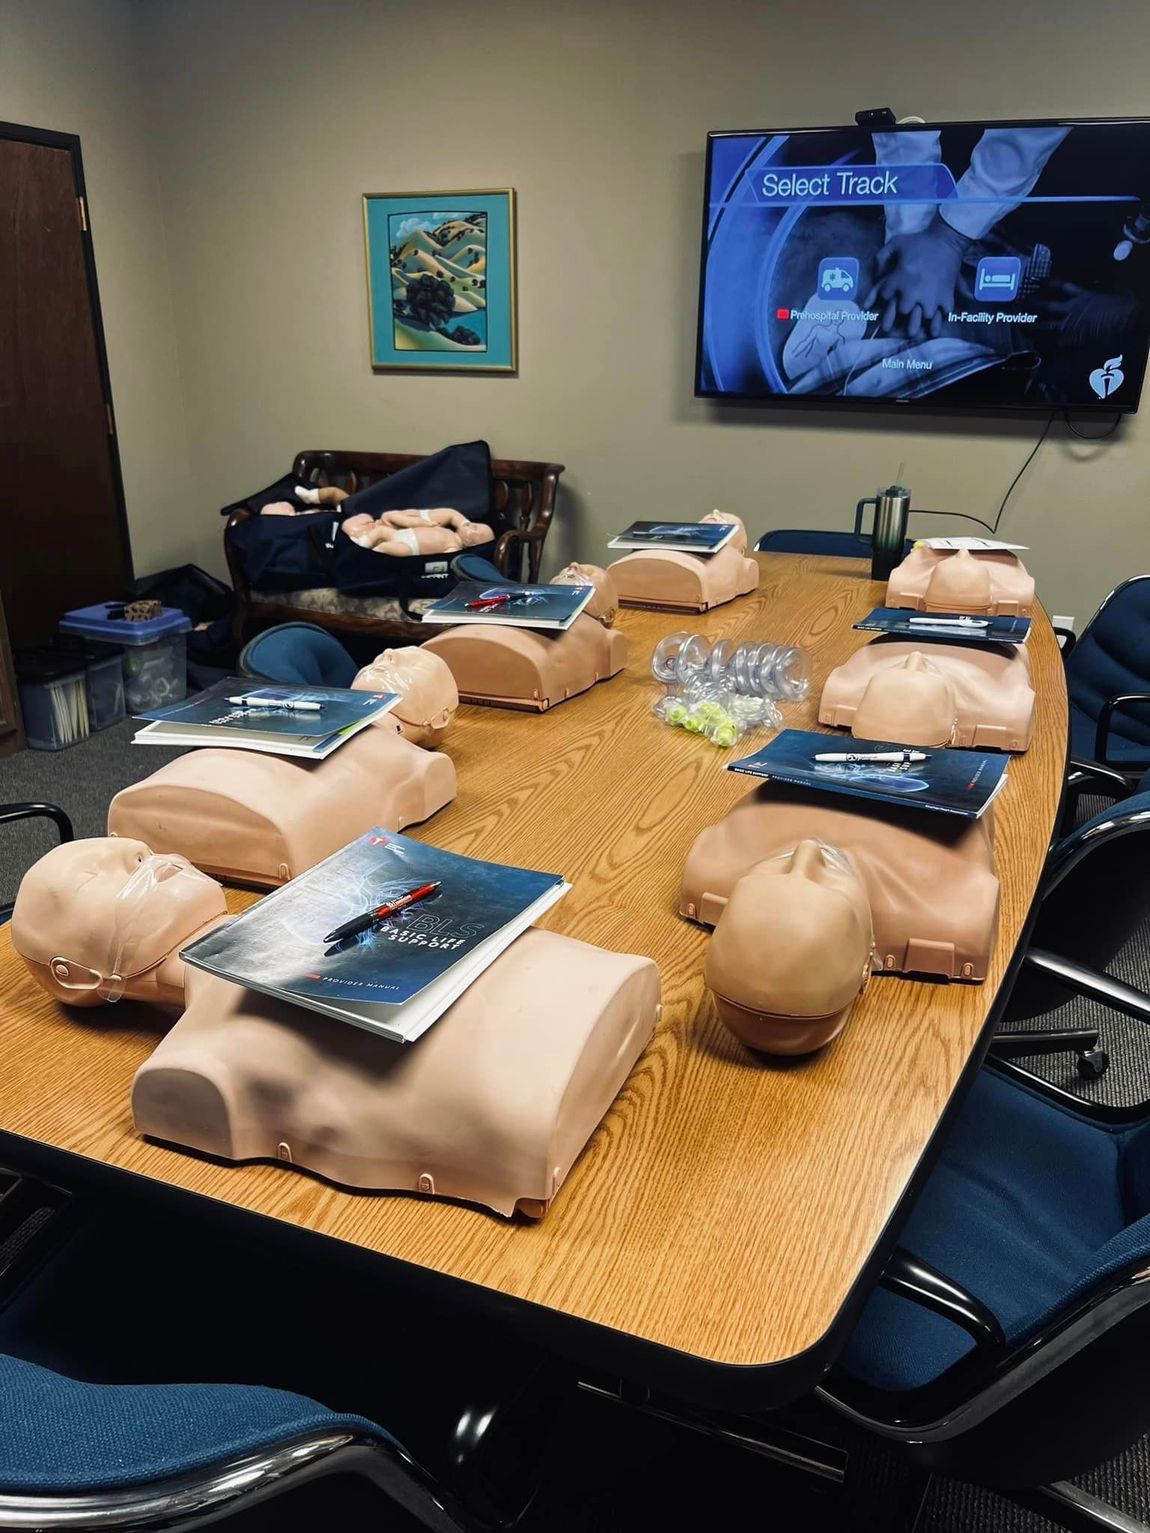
[0,124,132,647]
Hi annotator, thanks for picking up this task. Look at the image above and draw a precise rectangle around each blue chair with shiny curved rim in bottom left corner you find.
[0,1355,475,1533]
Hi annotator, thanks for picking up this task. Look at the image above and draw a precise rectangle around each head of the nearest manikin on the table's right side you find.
[704,840,874,1055]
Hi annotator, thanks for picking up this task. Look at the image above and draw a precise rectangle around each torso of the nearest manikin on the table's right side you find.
[679,783,998,987]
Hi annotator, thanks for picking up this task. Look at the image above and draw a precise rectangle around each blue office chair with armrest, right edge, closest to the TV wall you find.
[1063,575,1150,782]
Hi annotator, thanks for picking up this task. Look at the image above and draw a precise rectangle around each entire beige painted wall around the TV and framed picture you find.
[9,0,1150,622]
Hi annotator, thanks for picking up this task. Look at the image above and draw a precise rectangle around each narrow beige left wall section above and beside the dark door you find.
[0,0,202,576]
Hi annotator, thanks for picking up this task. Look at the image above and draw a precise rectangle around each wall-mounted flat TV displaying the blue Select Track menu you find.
[696,120,1150,412]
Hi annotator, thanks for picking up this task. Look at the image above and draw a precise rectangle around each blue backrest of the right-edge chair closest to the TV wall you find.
[1066,575,1150,745]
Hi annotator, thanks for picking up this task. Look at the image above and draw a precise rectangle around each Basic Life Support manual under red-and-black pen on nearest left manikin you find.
[181,829,567,1042]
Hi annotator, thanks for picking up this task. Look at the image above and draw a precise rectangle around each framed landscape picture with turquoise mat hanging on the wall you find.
[363,190,517,373]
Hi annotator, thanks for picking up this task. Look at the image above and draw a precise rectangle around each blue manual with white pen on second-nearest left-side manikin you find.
[135,676,399,760]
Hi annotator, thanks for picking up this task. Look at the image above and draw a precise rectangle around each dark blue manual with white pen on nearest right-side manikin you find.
[727,730,1007,820]
